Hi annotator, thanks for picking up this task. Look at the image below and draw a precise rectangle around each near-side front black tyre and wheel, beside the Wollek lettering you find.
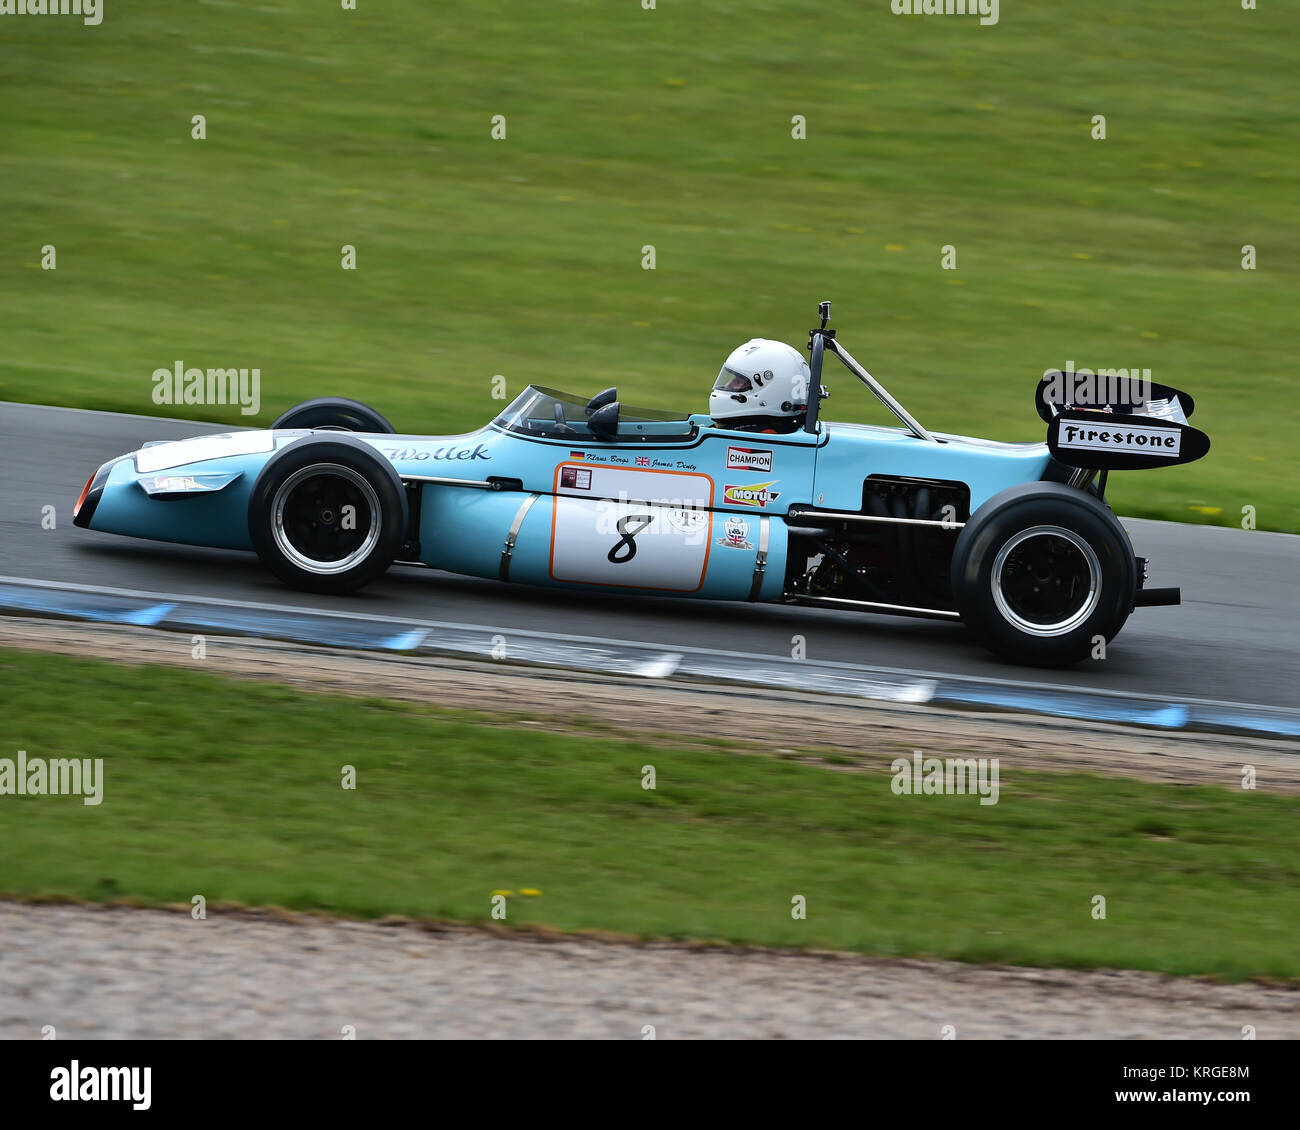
[248,436,407,593]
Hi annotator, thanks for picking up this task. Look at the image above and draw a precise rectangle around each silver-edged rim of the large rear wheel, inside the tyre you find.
[989,525,1101,637]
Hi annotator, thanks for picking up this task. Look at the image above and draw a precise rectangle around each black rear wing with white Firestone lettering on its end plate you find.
[1035,371,1210,471]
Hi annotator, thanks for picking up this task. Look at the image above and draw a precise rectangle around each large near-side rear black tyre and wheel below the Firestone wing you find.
[952,482,1138,667]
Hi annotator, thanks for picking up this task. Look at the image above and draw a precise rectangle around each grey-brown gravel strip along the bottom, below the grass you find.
[0,902,1300,1039]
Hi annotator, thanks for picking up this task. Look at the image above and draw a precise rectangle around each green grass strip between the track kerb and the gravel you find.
[0,651,1300,978]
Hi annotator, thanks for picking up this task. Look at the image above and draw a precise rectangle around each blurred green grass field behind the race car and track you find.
[0,0,1300,531]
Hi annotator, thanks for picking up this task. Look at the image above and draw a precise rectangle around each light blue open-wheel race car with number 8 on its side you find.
[74,303,1209,664]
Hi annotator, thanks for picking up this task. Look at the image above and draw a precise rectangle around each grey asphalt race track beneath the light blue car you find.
[0,402,1300,706]
